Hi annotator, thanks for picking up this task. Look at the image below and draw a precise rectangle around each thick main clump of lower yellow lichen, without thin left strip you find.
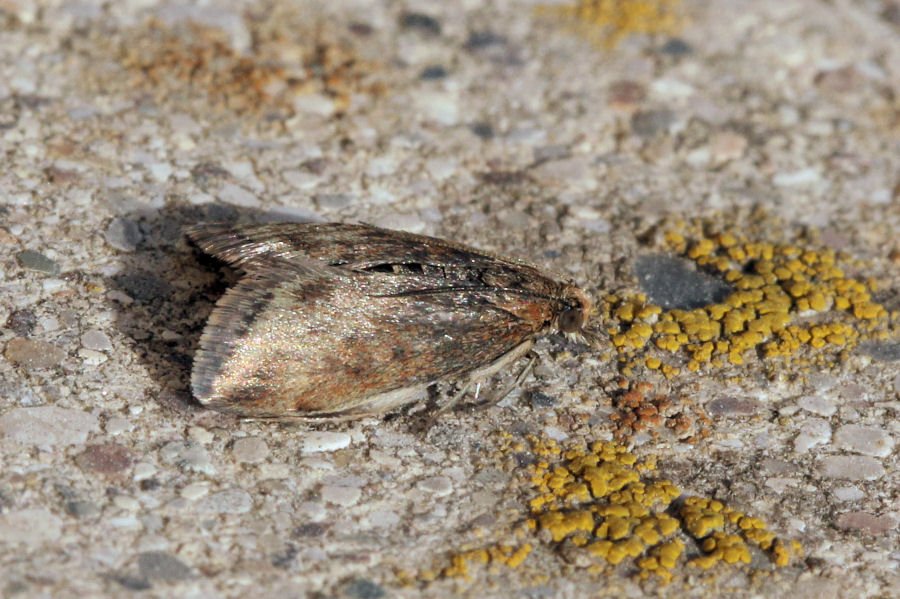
[512,436,797,582]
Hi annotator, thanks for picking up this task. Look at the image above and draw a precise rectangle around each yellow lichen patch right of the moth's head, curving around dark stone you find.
[598,221,897,378]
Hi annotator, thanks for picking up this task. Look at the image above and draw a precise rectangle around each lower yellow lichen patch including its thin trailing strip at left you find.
[430,434,801,584]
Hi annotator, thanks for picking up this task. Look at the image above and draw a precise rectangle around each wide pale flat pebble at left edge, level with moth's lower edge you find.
[0,406,99,447]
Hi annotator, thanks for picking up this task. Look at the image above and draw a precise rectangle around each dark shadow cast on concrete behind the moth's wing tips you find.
[105,202,310,413]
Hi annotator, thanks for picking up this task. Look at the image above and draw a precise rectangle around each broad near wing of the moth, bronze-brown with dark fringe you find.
[192,267,541,417]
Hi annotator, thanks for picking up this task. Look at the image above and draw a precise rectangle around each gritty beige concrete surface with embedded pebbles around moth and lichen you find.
[0,0,900,599]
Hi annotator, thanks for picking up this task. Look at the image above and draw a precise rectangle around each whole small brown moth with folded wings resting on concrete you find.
[187,223,591,419]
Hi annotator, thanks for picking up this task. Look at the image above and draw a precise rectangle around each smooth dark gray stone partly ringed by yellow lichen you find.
[634,256,734,310]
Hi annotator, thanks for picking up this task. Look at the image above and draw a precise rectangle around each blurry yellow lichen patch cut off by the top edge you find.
[538,0,684,47]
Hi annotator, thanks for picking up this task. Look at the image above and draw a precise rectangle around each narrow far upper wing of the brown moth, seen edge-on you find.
[186,223,546,277]
